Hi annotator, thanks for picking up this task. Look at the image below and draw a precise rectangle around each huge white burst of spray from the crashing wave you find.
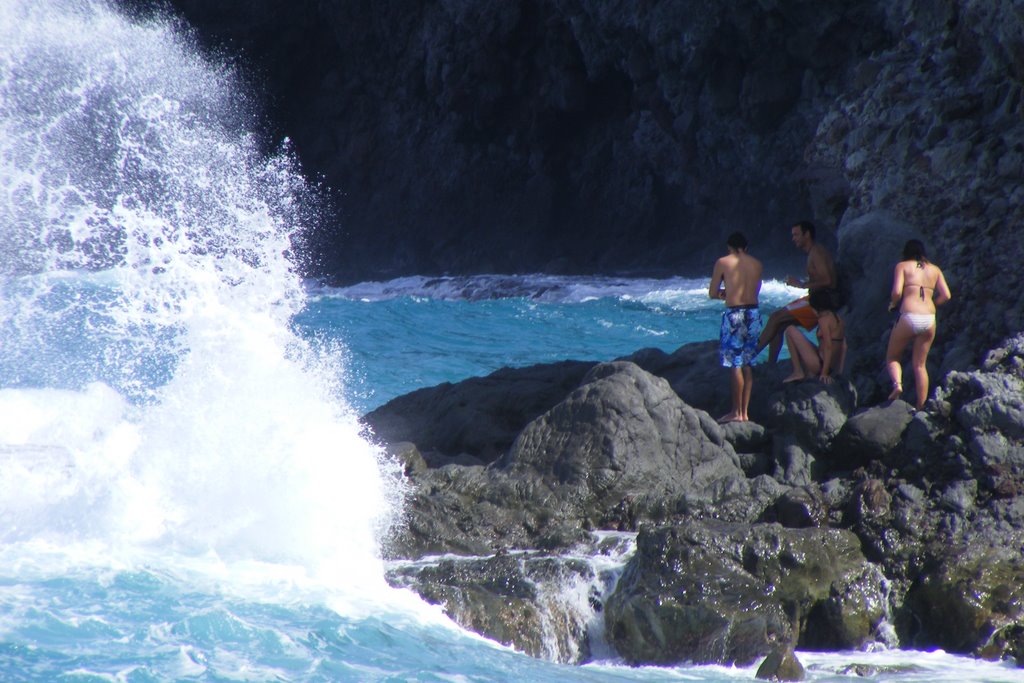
[0,0,400,591]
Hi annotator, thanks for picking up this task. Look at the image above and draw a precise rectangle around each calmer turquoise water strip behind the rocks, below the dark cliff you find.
[295,275,799,411]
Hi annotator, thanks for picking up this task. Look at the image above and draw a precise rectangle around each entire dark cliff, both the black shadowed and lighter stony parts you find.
[123,0,1024,362]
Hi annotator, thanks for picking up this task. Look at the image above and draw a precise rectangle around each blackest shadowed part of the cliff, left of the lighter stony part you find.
[123,0,894,280]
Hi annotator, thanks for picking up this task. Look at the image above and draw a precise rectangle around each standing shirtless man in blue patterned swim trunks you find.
[708,232,763,424]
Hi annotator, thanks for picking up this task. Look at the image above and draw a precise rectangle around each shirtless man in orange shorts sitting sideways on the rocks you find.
[757,220,839,364]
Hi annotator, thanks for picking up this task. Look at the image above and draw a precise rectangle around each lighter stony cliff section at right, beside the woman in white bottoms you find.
[806,0,1024,371]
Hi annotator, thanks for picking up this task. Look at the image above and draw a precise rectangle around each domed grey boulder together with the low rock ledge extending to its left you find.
[386,361,770,557]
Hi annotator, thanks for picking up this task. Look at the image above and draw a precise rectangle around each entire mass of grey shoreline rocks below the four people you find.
[367,335,1024,665]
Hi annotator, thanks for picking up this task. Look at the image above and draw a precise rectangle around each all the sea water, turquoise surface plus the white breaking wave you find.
[0,0,1024,683]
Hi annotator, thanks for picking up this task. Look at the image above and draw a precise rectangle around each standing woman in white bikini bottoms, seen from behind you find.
[886,240,952,411]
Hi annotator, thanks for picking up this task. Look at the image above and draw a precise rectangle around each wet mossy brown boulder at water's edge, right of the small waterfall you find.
[605,519,884,666]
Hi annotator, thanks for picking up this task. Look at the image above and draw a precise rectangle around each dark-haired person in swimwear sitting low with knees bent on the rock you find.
[782,290,846,384]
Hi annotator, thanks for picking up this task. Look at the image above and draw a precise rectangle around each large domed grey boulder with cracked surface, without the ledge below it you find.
[501,361,745,509]
